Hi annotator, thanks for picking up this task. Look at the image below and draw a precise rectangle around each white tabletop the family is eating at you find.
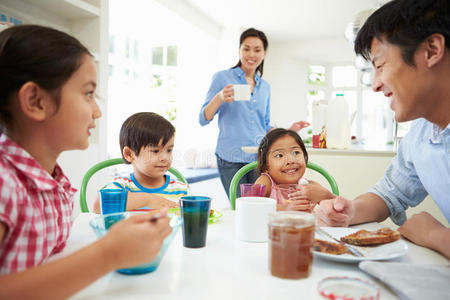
[62,211,449,300]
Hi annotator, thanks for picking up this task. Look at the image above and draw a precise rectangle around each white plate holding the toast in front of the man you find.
[314,227,408,263]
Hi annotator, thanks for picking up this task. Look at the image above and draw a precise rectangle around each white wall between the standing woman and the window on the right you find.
[263,36,355,127]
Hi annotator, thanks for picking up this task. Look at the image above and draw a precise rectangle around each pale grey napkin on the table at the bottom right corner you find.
[359,261,450,300]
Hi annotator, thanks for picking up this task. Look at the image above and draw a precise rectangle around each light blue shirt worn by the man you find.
[369,119,450,225]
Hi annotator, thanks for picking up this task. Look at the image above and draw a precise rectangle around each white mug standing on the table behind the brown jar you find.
[235,197,277,242]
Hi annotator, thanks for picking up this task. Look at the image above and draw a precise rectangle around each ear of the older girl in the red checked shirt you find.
[17,81,55,122]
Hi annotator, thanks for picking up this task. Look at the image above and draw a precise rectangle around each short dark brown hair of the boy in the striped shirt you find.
[119,112,175,164]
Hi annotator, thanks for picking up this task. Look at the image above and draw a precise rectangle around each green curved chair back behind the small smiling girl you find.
[229,161,339,210]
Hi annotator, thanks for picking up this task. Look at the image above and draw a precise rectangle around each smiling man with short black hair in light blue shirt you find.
[318,0,450,258]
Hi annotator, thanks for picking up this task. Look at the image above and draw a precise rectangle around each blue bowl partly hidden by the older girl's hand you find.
[89,212,183,275]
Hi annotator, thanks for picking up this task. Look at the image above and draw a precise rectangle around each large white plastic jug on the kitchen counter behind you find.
[326,94,351,149]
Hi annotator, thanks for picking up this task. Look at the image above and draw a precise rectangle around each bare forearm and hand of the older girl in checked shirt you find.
[0,214,171,299]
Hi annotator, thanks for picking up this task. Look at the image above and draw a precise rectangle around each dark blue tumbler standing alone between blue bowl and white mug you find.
[180,196,211,248]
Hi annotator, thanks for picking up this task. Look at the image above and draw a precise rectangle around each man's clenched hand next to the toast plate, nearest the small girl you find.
[316,197,355,227]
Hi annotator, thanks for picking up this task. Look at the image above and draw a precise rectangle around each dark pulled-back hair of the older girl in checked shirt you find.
[0,25,92,131]
